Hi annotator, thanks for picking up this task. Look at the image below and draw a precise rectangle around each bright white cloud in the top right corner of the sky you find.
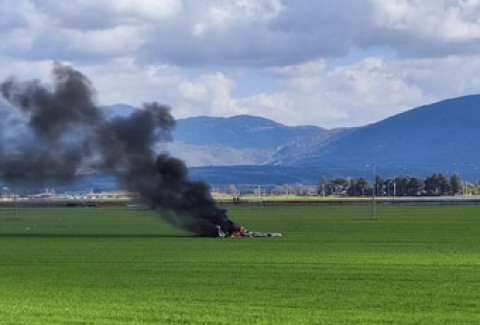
[373,0,480,57]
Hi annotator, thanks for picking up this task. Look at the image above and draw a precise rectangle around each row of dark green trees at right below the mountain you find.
[317,174,477,197]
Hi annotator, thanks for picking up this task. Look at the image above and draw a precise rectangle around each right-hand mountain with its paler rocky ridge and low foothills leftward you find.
[188,95,480,184]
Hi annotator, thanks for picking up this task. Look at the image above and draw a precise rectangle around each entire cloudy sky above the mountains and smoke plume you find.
[0,0,480,129]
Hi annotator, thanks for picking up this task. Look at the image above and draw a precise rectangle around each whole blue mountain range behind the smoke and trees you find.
[0,95,480,186]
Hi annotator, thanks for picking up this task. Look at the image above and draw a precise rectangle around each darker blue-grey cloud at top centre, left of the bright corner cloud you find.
[144,0,376,66]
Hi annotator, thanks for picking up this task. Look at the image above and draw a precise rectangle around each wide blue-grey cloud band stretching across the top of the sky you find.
[7,0,480,67]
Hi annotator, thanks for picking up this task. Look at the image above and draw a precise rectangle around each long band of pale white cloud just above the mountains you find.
[62,52,480,128]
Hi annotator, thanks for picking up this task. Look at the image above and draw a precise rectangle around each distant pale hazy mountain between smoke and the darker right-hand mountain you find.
[167,115,338,167]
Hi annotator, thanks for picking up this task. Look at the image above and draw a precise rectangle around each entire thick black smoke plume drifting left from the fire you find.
[0,63,238,236]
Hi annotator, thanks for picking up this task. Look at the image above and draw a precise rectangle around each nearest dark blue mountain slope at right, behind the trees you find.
[283,95,480,180]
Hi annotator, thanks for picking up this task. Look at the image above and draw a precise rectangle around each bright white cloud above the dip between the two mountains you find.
[231,57,425,128]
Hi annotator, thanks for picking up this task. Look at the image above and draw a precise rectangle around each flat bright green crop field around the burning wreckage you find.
[0,205,480,325]
